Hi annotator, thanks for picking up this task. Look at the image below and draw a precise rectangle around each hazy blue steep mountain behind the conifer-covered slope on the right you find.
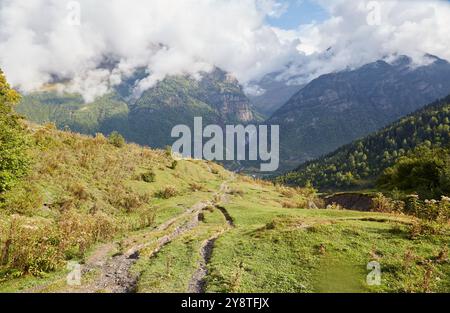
[269,56,450,168]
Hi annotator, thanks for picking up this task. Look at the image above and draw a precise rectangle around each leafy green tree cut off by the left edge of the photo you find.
[0,70,29,193]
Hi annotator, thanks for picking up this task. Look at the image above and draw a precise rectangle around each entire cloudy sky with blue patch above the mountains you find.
[0,0,450,101]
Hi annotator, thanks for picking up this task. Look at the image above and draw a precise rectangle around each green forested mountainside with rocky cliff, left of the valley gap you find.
[17,69,258,147]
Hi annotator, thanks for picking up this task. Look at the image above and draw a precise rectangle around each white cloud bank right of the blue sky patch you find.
[284,0,450,82]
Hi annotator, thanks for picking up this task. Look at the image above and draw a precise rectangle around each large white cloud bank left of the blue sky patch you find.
[0,0,295,100]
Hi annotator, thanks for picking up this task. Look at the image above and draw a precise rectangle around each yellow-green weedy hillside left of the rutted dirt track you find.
[0,125,170,280]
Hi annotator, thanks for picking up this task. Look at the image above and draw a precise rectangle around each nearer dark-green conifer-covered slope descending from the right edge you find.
[279,96,450,189]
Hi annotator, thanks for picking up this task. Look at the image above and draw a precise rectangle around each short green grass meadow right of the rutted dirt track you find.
[208,178,450,292]
